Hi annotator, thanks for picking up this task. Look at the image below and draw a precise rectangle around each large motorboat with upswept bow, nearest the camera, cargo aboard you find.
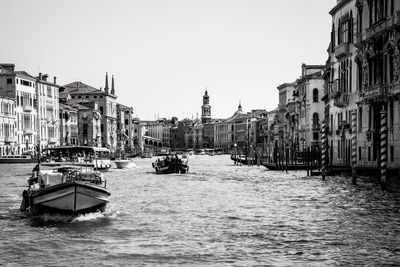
[21,148,110,215]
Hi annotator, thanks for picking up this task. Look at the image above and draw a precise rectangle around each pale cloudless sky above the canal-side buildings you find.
[0,0,337,120]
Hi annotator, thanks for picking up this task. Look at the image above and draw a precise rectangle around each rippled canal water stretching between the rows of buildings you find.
[0,156,400,266]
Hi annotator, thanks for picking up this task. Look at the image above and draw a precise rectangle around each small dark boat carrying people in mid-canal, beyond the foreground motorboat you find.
[152,155,189,174]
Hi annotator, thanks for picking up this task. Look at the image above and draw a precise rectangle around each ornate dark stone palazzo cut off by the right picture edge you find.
[354,0,400,172]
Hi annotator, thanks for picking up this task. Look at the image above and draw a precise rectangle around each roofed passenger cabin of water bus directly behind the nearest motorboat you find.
[42,146,110,162]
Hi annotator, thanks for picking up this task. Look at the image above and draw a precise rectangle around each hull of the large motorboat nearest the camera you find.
[29,182,110,215]
